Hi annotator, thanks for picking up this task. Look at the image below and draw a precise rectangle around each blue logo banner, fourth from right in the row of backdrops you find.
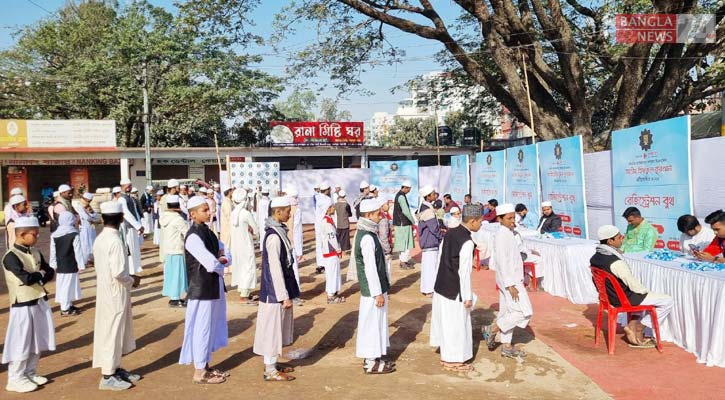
[471,150,506,203]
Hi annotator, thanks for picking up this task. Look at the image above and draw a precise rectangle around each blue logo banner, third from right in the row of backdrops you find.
[506,144,541,225]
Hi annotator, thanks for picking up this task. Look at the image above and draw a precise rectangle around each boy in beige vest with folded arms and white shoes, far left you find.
[2,217,55,393]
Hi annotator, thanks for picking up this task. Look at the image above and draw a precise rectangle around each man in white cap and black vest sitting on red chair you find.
[589,225,674,348]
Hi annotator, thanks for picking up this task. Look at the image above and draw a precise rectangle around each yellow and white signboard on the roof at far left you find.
[0,119,116,151]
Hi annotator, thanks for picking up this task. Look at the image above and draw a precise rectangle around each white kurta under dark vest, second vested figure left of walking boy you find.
[355,236,390,358]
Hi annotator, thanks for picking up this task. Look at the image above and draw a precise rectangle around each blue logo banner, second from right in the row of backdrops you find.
[538,136,587,238]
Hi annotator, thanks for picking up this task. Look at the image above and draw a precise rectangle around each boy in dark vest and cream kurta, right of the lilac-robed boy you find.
[253,196,300,382]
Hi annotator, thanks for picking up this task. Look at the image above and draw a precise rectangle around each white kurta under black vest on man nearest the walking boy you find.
[430,239,476,362]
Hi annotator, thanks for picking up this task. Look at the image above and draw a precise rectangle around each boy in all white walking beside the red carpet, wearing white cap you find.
[483,203,533,360]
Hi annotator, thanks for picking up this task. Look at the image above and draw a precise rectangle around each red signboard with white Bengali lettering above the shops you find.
[270,121,365,146]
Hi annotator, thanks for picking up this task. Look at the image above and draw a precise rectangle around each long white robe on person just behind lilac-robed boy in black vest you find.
[230,204,258,291]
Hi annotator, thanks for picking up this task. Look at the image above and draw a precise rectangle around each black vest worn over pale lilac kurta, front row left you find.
[184,223,226,300]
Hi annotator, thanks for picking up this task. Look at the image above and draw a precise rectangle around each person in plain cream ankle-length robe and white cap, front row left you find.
[92,201,141,391]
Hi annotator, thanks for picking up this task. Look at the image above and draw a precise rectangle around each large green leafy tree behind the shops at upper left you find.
[0,0,282,147]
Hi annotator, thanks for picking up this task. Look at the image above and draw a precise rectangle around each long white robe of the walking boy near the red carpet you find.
[491,226,533,343]
